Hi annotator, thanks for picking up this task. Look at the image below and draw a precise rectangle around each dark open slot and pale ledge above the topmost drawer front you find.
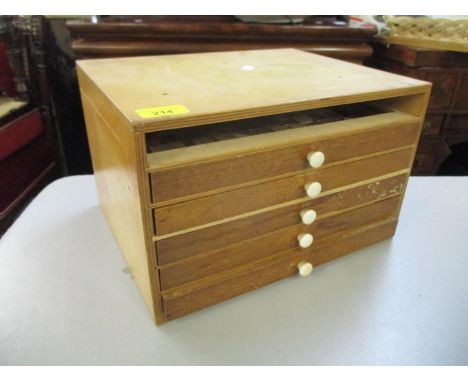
[146,108,418,168]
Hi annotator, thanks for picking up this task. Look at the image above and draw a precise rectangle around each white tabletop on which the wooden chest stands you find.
[0,176,468,365]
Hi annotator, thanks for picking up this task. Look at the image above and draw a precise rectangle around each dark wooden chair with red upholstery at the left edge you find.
[0,16,60,235]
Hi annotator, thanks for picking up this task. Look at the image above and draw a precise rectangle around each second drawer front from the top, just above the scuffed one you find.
[154,148,413,236]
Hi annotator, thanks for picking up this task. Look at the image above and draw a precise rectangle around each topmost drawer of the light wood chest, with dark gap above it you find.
[147,103,420,205]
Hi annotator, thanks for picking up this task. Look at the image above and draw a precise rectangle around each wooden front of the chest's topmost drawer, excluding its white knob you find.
[150,123,419,203]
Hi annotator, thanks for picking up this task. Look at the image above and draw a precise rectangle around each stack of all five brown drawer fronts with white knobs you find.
[148,112,420,319]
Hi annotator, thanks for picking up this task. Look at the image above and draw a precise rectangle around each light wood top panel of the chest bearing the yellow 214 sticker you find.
[77,49,429,130]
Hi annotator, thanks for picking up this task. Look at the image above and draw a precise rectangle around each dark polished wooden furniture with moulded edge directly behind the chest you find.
[67,16,376,63]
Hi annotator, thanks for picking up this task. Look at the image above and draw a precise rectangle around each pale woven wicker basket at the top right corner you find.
[381,16,468,52]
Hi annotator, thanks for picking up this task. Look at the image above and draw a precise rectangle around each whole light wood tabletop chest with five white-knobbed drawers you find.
[78,49,430,323]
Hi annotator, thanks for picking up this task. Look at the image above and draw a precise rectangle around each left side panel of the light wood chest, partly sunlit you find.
[78,69,164,323]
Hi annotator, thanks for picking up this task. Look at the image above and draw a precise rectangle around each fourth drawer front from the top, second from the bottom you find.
[160,197,401,290]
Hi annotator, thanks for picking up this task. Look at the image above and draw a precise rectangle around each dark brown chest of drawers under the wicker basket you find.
[369,43,468,175]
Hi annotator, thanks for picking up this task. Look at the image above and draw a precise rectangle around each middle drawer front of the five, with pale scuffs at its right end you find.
[156,174,407,265]
